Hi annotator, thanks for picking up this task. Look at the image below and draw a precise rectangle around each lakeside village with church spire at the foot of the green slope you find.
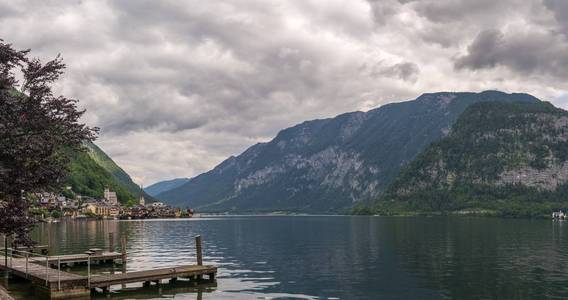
[32,187,194,222]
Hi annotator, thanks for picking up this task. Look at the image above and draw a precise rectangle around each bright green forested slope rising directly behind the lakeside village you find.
[66,142,153,203]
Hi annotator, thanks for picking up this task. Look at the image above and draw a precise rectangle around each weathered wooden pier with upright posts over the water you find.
[0,237,217,299]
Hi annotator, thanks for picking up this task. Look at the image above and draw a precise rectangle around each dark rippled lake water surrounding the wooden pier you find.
[3,216,568,299]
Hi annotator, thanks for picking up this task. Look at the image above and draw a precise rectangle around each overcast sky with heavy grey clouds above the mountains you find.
[0,0,568,185]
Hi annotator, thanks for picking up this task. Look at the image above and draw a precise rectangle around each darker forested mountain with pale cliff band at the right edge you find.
[377,102,568,216]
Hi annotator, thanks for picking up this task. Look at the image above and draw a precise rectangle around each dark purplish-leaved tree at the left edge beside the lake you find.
[0,39,98,244]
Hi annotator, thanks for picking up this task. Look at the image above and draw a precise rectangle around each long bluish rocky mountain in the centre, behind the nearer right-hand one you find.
[156,91,539,213]
